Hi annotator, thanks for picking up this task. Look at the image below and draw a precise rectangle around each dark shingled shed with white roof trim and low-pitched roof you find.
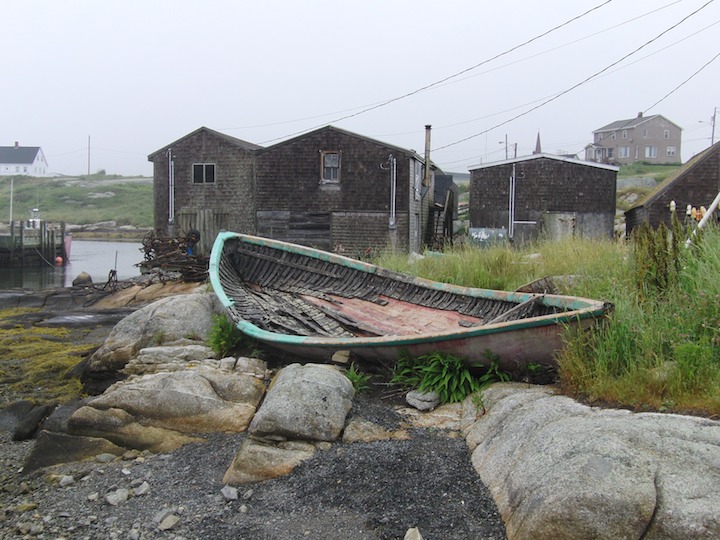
[470,153,618,241]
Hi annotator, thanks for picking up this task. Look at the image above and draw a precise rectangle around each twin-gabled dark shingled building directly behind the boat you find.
[148,126,444,256]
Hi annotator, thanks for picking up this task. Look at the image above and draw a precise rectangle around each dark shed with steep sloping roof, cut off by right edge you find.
[625,142,720,235]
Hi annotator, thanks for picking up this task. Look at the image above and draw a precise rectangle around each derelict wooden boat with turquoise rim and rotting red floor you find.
[209,232,612,371]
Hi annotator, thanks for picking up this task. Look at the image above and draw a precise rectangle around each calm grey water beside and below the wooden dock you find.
[0,240,143,289]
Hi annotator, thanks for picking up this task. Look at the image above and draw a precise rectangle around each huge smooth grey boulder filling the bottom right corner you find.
[467,384,720,540]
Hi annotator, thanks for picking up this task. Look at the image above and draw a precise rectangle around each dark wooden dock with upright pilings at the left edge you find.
[0,220,71,266]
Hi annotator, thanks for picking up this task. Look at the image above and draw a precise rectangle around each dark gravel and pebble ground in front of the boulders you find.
[0,392,505,540]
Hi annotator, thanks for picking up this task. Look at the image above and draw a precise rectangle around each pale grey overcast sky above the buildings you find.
[5,0,720,176]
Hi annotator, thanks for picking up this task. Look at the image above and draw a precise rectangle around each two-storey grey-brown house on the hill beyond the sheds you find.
[585,113,682,165]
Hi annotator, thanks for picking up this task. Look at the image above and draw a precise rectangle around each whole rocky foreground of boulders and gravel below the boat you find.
[0,283,720,540]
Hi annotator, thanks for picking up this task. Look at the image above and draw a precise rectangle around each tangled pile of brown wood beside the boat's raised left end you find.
[140,231,209,281]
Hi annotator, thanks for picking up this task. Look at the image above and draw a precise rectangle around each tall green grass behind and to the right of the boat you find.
[379,228,720,416]
